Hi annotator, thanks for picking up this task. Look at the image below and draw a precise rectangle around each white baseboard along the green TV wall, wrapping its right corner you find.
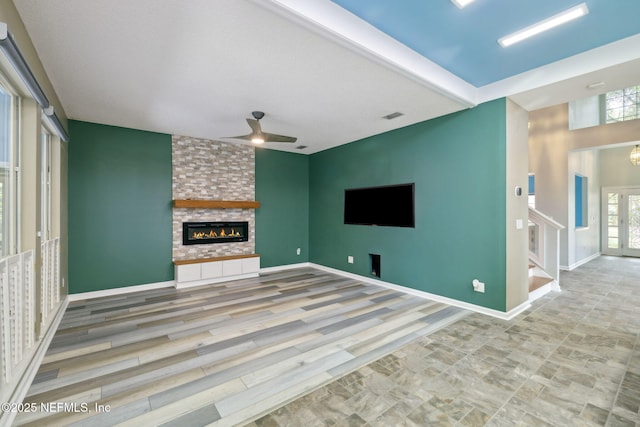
[308,263,531,320]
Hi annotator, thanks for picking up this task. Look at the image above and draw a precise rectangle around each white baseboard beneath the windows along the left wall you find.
[0,297,69,426]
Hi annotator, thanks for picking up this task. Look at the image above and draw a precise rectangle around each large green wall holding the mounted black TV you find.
[309,99,506,311]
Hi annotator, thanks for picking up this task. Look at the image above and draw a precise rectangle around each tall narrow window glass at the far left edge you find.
[0,81,19,257]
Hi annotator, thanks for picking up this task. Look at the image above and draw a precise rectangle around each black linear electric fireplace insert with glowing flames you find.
[182,221,249,245]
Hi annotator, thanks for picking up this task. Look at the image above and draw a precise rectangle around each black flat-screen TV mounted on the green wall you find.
[344,184,415,227]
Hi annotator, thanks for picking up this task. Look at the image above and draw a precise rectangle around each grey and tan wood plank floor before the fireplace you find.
[16,268,468,427]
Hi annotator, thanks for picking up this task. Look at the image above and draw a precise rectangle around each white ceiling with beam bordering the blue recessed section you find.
[9,0,640,154]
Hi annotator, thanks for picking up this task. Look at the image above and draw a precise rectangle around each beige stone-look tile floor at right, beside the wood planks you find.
[248,257,640,427]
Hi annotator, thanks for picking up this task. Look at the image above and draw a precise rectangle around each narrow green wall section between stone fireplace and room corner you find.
[256,148,309,268]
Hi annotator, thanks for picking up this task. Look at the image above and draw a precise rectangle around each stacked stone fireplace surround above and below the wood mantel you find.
[172,135,255,262]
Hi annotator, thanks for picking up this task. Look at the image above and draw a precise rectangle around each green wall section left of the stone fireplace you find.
[69,121,173,293]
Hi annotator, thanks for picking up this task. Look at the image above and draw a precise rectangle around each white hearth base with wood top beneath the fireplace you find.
[174,255,260,288]
